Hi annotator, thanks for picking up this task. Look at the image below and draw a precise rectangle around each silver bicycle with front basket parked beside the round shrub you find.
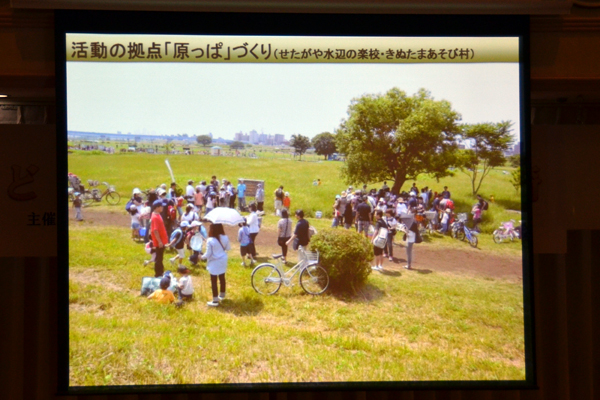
[251,246,329,295]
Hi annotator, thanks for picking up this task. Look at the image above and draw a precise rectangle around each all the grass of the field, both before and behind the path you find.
[69,153,525,386]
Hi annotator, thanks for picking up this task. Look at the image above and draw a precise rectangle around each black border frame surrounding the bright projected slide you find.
[55,10,537,395]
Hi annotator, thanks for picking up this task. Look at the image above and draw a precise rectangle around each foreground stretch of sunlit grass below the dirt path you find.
[69,223,524,385]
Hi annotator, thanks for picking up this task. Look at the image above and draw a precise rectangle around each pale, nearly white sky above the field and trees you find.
[67,62,520,139]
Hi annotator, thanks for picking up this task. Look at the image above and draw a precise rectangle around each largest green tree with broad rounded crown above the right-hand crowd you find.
[336,88,461,192]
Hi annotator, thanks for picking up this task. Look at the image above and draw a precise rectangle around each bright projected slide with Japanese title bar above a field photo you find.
[64,34,526,387]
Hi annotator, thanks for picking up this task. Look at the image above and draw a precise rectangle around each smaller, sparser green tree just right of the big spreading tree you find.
[460,121,513,195]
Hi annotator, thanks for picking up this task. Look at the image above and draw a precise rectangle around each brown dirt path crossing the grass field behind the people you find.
[69,208,523,281]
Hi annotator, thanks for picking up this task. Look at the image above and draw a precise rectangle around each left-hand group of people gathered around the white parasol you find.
[116,176,309,307]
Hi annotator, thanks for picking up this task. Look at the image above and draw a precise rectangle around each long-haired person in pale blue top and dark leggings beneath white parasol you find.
[202,224,231,307]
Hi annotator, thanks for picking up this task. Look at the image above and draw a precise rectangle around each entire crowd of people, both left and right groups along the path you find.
[73,170,487,306]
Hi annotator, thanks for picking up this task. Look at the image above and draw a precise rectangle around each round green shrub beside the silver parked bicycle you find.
[310,229,373,295]
